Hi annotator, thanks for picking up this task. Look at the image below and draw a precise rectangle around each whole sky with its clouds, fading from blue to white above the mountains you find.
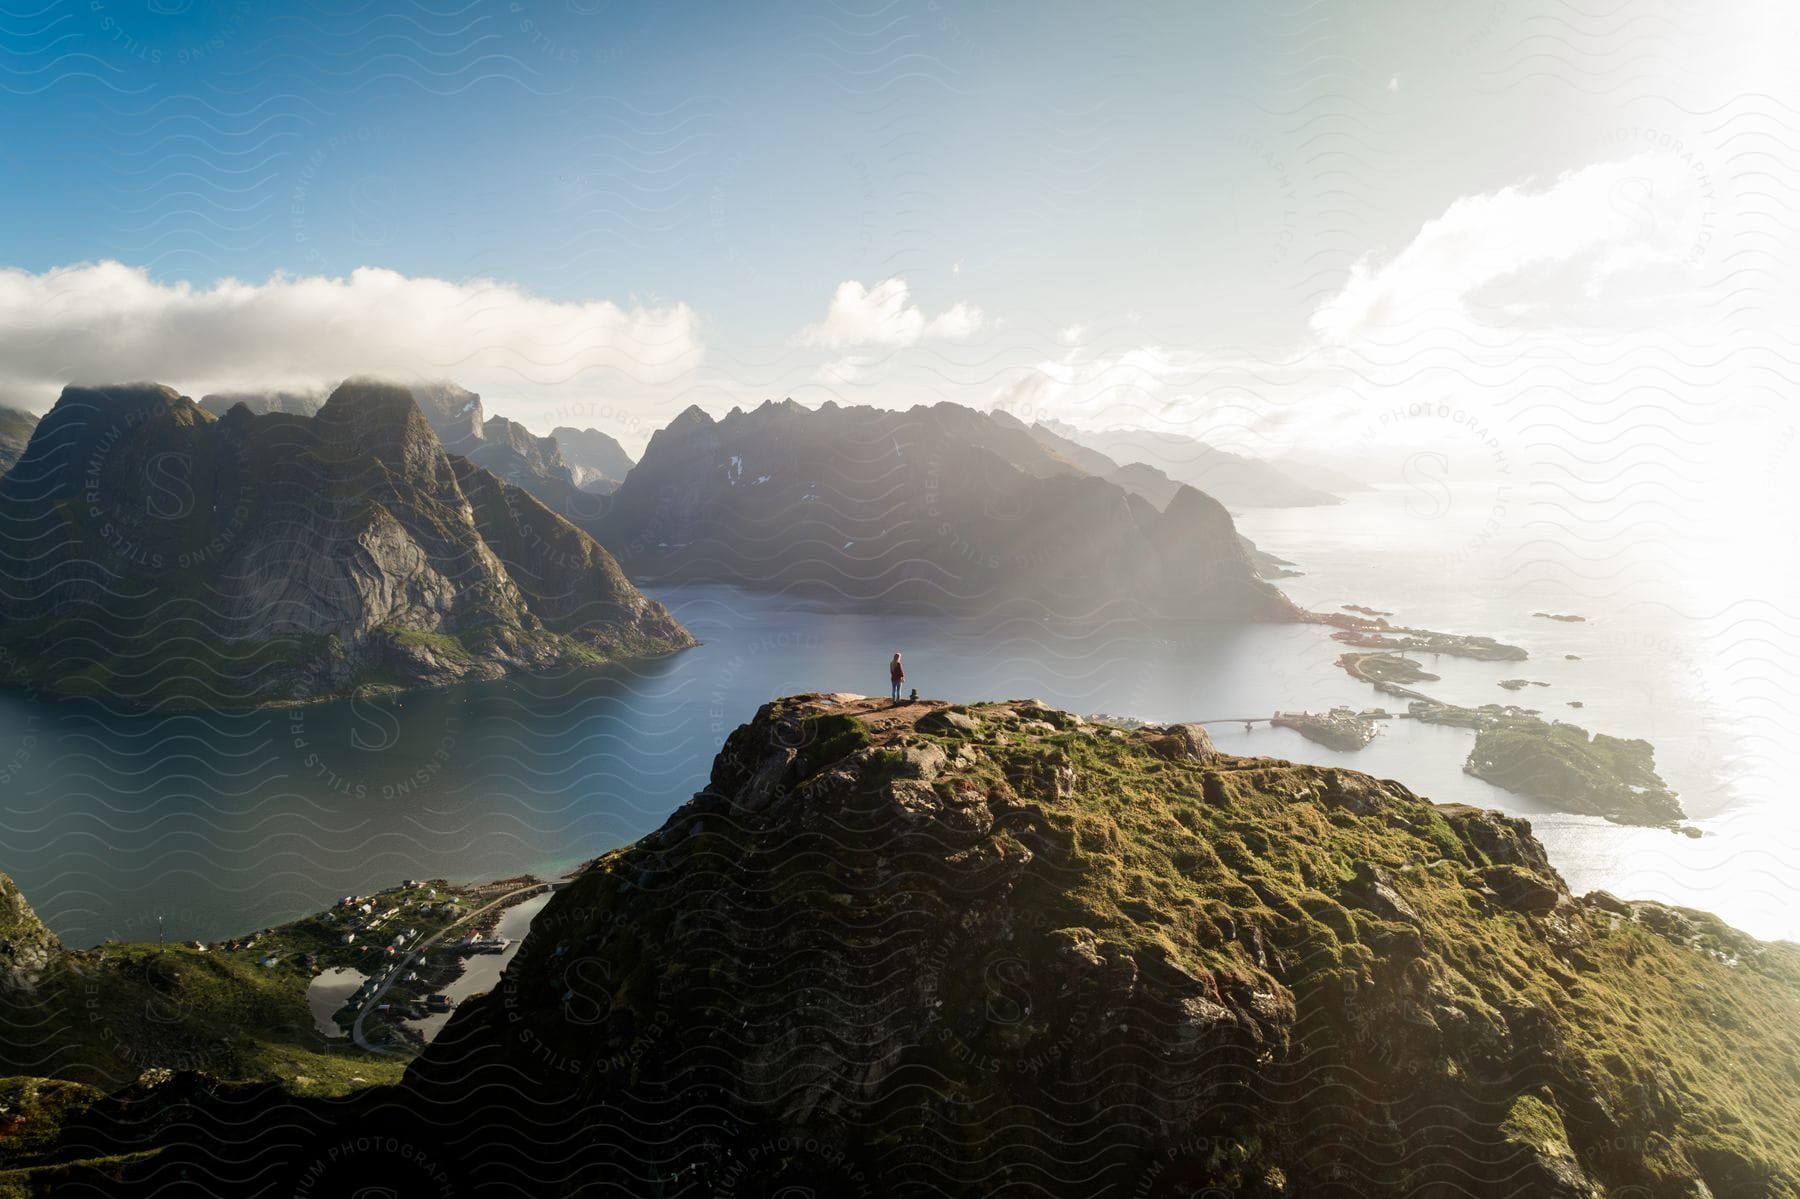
[0,0,1793,460]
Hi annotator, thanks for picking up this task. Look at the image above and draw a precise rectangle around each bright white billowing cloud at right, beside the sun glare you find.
[1312,155,1706,342]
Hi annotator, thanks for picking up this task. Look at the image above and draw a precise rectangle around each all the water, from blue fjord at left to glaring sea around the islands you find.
[0,493,1800,945]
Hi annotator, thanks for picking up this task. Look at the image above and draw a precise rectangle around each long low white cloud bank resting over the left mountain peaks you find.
[0,261,702,418]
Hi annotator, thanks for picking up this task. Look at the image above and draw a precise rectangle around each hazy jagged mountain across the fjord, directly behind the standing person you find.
[599,401,1296,619]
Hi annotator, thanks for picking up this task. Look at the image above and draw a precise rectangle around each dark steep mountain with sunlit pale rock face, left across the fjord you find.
[0,382,691,706]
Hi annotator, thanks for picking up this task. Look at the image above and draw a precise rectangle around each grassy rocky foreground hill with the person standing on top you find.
[409,697,1800,1199]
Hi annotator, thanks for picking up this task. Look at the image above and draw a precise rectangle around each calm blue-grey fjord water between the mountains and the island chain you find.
[0,587,1363,945]
